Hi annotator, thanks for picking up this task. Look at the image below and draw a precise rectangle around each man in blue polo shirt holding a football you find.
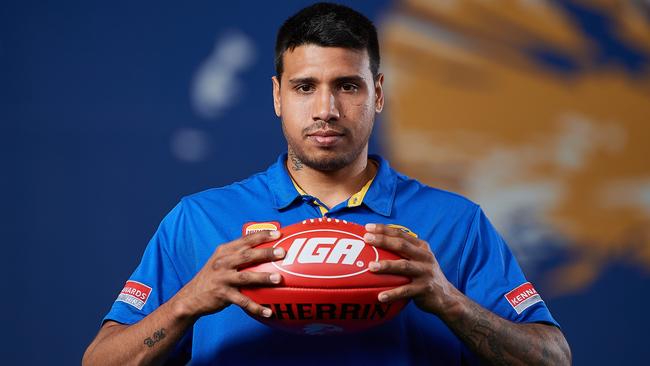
[84,4,571,365]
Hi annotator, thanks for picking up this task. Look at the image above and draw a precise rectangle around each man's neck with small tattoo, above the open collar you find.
[287,148,377,207]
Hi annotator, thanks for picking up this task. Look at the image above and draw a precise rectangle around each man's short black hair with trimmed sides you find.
[275,3,379,79]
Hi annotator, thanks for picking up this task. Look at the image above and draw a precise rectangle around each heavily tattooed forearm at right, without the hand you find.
[442,292,571,365]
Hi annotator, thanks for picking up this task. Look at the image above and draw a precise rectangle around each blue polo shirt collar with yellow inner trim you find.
[267,153,397,216]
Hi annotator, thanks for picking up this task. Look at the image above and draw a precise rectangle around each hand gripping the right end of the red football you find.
[363,224,458,314]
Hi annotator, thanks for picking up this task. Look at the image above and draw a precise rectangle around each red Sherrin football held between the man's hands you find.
[241,218,410,334]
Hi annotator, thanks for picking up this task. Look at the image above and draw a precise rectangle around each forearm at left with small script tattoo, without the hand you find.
[83,298,195,365]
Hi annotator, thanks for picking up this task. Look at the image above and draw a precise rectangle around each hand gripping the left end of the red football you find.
[174,230,286,318]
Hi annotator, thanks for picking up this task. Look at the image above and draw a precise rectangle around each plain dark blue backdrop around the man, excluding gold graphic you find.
[0,1,650,365]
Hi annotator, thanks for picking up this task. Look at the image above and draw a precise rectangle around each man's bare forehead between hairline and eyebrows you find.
[282,44,371,80]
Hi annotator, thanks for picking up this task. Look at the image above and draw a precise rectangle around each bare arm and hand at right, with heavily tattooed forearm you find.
[364,224,571,365]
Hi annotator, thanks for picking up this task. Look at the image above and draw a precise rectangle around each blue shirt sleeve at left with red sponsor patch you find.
[102,201,191,324]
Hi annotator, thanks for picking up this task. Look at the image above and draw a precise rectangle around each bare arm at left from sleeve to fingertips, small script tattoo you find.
[82,231,285,365]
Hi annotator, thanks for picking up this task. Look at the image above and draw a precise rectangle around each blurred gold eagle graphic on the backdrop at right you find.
[380,0,650,294]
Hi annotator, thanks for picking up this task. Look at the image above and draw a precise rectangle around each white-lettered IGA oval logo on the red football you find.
[273,229,379,278]
